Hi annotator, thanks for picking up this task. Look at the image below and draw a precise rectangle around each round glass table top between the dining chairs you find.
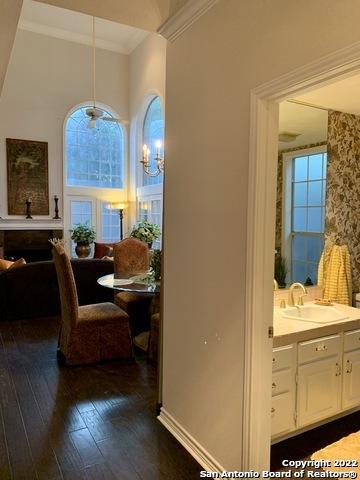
[97,273,160,295]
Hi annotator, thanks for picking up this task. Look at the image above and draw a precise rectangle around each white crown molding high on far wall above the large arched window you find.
[18,20,133,55]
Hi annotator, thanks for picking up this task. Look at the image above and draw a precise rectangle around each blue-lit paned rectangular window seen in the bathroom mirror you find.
[291,152,327,284]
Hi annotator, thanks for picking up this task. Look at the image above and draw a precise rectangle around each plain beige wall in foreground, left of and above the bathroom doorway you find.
[163,0,360,470]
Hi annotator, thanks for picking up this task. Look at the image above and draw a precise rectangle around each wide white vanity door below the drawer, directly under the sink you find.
[297,355,341,427]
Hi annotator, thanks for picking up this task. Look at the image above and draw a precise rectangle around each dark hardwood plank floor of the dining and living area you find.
[0,318,201,480]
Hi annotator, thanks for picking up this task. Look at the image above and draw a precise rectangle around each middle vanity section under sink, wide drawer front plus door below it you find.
[297,335,342,428]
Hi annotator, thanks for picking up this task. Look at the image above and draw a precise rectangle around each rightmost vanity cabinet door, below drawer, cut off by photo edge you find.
[342,350,360,410]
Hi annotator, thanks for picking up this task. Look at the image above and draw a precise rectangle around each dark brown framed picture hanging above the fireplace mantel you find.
[6,138,49,215]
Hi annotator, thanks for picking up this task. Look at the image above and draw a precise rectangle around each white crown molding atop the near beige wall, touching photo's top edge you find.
[157,0,219,42]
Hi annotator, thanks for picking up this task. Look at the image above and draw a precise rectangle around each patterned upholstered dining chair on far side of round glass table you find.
[114,237,152,337]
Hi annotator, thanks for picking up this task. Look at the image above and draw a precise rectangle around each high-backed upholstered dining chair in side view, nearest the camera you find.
[53,245,132,365]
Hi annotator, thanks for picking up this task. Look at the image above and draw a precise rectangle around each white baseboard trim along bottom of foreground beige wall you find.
[158,407,225,472]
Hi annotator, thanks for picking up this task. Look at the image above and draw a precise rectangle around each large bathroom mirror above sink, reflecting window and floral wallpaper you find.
[275,97,360,295]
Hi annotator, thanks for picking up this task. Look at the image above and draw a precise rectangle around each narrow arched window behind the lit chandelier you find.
[142,97,164,186]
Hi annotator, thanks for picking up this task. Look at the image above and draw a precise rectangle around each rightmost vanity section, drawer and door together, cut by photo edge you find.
[342,330,360,410]
